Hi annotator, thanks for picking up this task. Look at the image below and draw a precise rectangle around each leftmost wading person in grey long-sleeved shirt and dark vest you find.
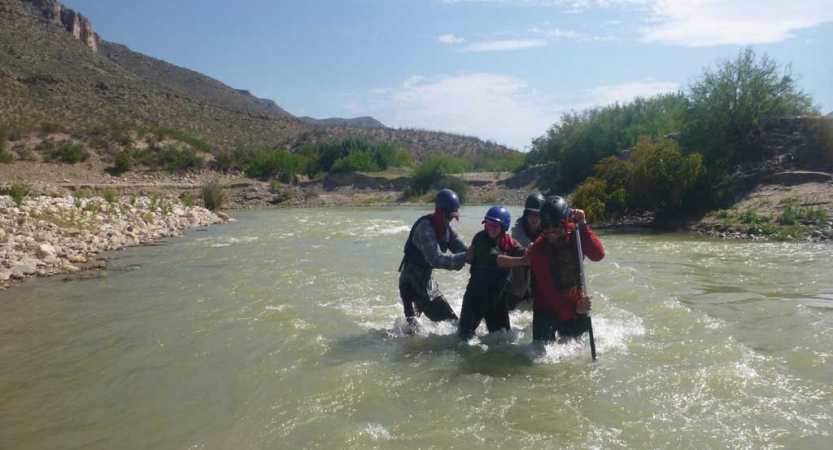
[399,189,467,331]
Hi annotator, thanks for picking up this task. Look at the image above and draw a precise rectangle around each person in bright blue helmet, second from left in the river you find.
[457,205,529,339]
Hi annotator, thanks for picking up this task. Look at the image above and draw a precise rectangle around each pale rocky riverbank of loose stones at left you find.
[0,195,234,290]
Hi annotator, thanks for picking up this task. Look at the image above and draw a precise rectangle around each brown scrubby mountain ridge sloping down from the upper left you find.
[0,0,515,160]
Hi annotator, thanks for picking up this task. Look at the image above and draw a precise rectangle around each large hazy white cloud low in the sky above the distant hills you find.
[361,73,680,149]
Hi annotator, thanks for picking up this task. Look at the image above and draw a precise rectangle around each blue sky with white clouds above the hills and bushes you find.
[62,0,833,150]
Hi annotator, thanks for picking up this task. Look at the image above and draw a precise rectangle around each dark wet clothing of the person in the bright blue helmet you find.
[457,230,523,339]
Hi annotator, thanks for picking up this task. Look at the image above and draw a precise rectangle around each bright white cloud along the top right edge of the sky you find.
[444,0,833,47]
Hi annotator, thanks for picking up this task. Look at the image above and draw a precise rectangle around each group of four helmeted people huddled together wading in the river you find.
[399,189,604,341]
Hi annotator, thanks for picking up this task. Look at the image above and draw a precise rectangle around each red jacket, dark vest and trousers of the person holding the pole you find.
[530,223,604,341]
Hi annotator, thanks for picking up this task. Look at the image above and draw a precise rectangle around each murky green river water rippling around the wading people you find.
[0,207,833,449]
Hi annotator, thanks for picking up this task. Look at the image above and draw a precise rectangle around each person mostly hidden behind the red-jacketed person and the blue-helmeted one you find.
[506,192,544,311]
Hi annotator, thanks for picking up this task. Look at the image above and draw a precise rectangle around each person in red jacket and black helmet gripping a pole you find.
[530,196,605,341]
